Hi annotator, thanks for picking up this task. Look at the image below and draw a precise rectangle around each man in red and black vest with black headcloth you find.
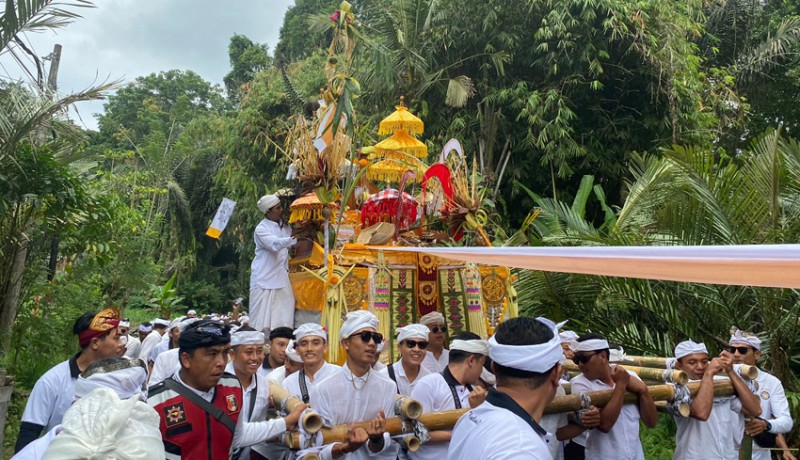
[147,320,306,460]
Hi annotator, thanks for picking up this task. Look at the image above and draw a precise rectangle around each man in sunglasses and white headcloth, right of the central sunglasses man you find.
[380,324,430,396]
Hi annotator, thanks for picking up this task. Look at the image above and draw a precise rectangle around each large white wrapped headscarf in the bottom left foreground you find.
[42,388,166,460]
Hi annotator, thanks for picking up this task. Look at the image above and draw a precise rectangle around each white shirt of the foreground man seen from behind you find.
[440,389,552,460]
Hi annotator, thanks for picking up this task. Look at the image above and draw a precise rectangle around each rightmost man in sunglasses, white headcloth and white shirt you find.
[726,327,793,460]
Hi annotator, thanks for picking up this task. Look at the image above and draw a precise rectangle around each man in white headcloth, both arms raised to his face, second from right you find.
[672,340,761,460]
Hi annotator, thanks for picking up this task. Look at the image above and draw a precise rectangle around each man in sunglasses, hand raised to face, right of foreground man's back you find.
[571,334,658,460]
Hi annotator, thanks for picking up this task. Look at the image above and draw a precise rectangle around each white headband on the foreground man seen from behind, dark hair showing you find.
[489,318,564,373]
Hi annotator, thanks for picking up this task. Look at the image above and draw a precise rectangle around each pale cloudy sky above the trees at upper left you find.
[0,0,294,128]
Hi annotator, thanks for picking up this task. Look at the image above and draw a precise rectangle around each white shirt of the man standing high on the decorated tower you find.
[250,219,295,290]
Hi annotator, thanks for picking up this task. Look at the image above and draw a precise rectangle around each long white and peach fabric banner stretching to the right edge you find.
[374,244,800,288]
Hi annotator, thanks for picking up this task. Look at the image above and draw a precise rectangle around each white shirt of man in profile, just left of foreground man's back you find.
[408,373,469,460]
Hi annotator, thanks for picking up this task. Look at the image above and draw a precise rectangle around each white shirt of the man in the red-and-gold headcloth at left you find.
[22,355,80,431]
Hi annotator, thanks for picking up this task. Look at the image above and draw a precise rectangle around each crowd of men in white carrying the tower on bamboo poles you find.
[6,302,794,460]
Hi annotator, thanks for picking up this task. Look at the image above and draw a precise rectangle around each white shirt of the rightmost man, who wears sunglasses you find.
[733,368,794,460]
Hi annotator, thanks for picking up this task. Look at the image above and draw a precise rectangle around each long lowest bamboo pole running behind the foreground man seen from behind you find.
[283,380,734,449]
